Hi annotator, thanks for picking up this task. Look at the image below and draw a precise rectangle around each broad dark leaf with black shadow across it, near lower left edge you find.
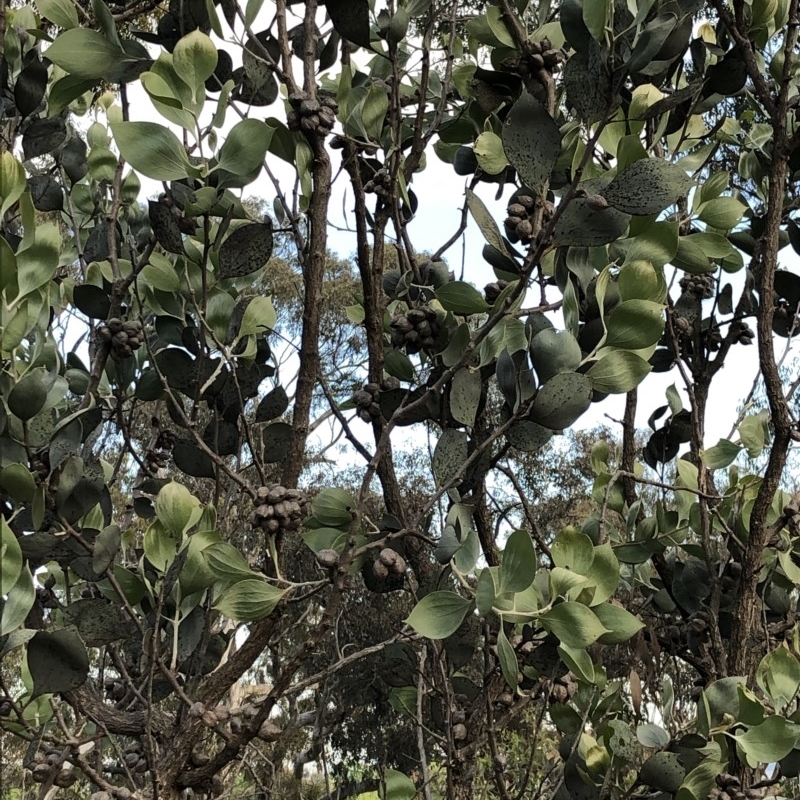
[27,630,89,698]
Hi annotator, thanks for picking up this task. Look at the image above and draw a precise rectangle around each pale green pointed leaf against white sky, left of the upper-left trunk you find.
[111,122,194,181]
